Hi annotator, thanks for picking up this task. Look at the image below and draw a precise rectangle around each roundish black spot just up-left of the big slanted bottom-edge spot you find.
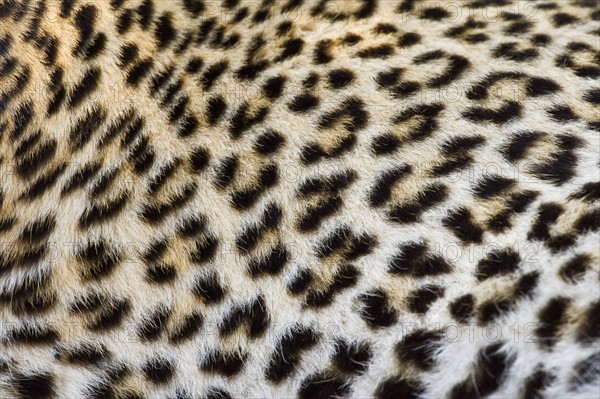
[396,330,444,370]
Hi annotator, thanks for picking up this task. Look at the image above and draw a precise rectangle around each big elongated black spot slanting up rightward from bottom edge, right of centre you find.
[449,343,514,399]
